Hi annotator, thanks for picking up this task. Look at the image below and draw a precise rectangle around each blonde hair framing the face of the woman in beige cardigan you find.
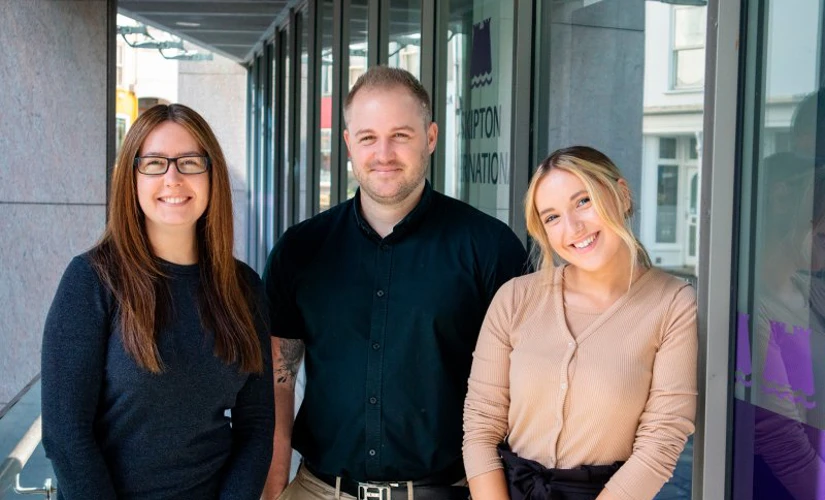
[524,146,652,282]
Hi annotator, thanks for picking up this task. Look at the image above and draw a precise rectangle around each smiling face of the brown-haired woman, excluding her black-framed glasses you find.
[135,121,209,240]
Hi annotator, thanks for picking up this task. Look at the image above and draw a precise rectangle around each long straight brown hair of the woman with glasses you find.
[92,104,263,373]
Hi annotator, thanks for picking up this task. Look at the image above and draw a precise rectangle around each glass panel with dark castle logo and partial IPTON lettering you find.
[441,0,514,221]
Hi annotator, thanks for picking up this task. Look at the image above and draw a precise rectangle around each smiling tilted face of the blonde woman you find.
[535,168,630,273]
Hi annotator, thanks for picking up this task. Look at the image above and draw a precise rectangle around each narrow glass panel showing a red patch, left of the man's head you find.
[318,0,334,212]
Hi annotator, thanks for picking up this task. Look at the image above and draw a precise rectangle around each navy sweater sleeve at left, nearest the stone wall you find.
[41,257,116,500]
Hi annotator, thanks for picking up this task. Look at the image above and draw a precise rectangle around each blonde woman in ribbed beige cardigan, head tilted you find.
[464,146,697,500]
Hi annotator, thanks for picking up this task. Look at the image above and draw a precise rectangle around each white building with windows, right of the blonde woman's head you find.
[639,2,707,274]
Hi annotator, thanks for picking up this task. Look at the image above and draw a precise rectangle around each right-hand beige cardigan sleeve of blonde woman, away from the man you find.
[606,286,698,500]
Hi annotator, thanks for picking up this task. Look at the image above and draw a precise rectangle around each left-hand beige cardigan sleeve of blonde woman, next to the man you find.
[463,280,514,479]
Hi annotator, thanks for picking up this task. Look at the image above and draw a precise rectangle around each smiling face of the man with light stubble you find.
[344,87,438,205]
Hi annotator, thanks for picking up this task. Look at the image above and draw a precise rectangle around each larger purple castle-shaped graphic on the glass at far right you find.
[762,321,816,409]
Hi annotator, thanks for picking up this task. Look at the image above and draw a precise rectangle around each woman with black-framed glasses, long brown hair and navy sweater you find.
[42,104,274,500]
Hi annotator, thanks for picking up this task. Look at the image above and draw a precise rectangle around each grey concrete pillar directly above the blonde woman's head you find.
[537,0,645,231]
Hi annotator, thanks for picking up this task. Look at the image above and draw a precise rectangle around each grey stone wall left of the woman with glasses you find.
[0,0,115,408]
